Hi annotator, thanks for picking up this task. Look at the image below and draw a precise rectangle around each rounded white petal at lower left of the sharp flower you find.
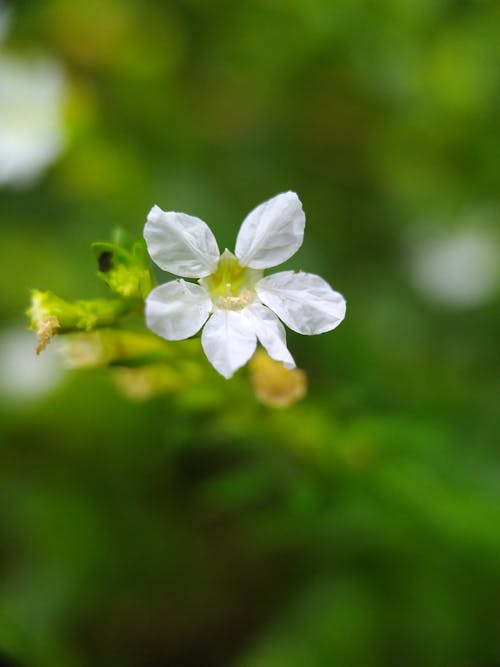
[146,280,212,340]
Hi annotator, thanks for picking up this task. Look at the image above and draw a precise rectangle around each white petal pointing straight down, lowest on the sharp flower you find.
[201,309,257,379]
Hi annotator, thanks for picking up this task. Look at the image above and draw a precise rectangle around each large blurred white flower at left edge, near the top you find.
[0,53,66,186]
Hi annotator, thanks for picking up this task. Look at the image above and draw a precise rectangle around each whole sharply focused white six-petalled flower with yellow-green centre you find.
[144,192,346,378]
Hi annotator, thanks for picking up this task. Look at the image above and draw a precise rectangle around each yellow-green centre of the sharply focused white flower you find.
[199,250,262,310]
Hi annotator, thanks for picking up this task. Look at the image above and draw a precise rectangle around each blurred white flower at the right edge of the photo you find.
[409,226,500,308]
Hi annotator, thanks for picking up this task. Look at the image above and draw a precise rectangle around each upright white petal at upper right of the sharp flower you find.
[235,192,306,269]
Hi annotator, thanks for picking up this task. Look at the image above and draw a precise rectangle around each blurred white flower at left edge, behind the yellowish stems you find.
[0,327,63,403]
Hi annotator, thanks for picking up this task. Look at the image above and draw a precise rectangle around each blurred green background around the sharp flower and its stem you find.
[0,0,500,667]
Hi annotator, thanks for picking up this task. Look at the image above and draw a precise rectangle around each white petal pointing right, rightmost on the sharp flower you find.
[255,271,346,336]
